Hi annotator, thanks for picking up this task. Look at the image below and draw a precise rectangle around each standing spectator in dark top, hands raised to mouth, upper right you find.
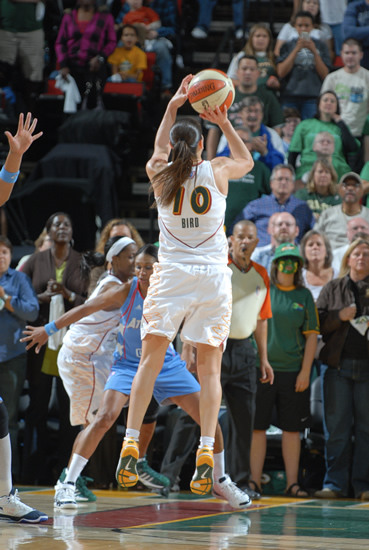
[277,11,331,120]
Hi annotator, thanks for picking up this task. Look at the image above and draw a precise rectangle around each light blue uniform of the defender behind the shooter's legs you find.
[105,277,200,403]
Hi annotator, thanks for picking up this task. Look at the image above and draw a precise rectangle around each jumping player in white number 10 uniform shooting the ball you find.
[118,75,253,495]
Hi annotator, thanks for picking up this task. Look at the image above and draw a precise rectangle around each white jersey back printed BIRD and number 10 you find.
[158,161,228,265]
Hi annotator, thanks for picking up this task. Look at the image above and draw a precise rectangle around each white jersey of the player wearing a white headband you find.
[63,274,123,361]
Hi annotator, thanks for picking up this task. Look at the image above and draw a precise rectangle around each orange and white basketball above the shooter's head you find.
[188,69,235,113]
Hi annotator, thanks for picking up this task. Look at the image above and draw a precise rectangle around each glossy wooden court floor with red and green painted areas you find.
[0,488,369,550]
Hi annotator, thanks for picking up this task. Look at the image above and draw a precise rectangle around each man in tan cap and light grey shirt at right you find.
[314,172,369,250]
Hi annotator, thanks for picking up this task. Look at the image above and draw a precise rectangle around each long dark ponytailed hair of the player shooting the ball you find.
[152,117,202,206]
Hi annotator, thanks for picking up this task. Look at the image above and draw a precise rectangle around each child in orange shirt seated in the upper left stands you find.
[108,25,147,82]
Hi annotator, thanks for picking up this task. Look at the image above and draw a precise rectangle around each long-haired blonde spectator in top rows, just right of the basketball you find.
[227,23,280,90]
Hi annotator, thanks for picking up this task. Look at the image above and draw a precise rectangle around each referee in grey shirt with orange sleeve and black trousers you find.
[221,220,274,499]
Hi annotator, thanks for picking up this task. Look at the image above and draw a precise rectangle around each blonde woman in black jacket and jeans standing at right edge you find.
[315,238,369,501]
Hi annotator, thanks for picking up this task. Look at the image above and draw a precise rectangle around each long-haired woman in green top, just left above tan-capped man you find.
[295,159,342,220]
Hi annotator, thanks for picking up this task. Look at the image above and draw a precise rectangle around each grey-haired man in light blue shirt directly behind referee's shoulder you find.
[251,212,299,274]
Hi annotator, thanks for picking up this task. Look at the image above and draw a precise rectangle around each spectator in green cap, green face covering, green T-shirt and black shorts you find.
[250,243,319,498]
